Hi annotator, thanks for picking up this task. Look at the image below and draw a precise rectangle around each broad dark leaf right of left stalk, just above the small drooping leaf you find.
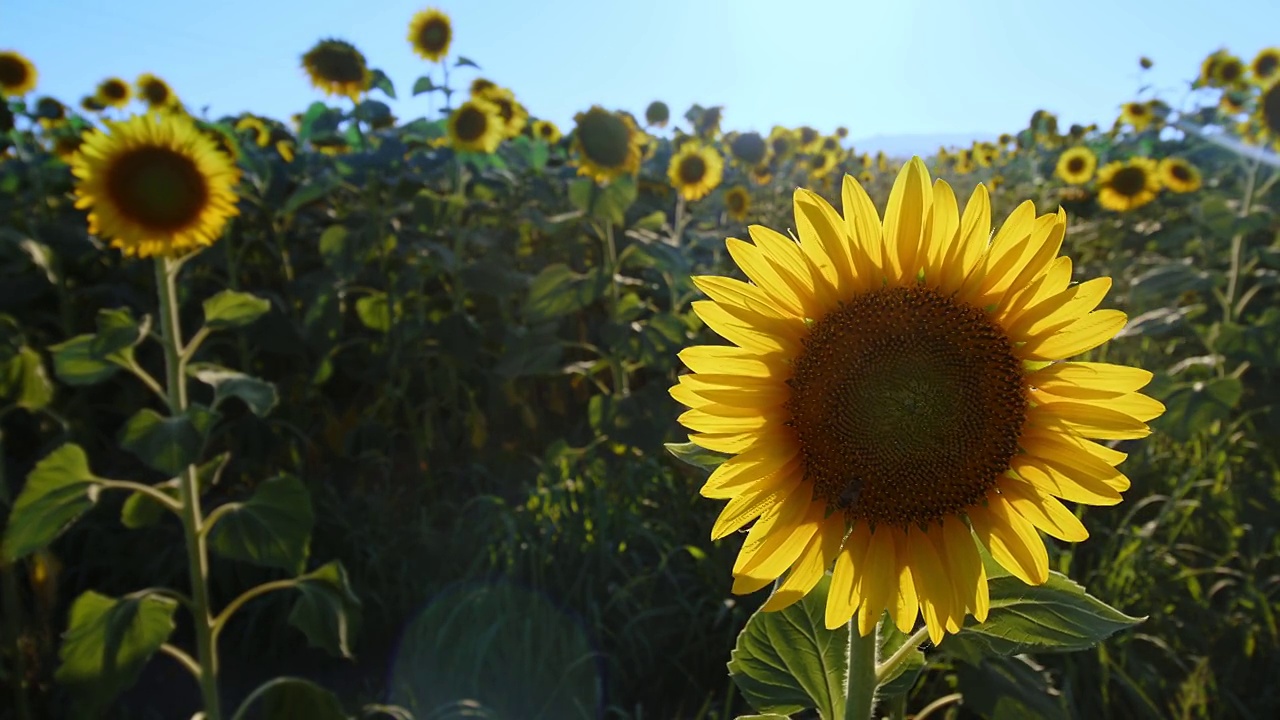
[209,475,315,573]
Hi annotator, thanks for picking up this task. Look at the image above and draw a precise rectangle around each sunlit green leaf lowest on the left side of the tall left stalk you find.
[54,591,178,717]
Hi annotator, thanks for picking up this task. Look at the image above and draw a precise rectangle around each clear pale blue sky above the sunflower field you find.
[0,0,1280,138]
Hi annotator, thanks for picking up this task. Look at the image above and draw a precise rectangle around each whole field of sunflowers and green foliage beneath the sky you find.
[0,9,1280,720]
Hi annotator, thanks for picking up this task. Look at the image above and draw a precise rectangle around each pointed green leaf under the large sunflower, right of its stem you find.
[938,571,1146,664]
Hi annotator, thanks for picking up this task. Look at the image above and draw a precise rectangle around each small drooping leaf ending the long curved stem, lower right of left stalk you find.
[289,560,360,659]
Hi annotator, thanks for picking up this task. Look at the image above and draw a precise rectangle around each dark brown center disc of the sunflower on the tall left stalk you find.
[106,147,209,232]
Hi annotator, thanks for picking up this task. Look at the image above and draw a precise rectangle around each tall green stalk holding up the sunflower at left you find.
[156,258,223,720]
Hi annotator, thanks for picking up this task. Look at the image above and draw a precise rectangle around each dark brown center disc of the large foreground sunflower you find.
[787,287,1027,525]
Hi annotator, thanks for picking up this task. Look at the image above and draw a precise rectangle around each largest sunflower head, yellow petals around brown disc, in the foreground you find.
[671,158,1164,642]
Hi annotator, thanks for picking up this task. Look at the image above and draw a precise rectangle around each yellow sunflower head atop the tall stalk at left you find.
[72,114,239,258]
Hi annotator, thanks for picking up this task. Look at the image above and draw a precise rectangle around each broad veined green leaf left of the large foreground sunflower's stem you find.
[728,577,849,717]
